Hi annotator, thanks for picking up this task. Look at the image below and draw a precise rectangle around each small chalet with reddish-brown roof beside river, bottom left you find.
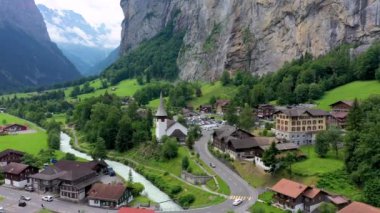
[87,183,133,209]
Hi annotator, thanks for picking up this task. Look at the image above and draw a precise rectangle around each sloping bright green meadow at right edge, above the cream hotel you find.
[316,81,380,110]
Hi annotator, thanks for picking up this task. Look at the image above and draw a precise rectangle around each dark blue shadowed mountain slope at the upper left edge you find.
[0,0,80,91]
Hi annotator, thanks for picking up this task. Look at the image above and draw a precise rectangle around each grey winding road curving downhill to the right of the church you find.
[168,131,259,213]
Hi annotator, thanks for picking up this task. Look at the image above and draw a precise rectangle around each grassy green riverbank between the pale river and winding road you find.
[65,128,230,209]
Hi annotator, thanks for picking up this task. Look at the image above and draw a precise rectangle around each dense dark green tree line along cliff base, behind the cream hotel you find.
[220,42,380,107]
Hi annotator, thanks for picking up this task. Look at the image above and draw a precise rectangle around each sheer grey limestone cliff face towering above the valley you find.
[121,0,380,80]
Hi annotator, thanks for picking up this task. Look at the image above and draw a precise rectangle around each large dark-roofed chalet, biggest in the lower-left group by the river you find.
[31,160,104,201]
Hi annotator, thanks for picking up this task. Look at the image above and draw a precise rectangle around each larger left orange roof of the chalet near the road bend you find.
[272,178,307,198]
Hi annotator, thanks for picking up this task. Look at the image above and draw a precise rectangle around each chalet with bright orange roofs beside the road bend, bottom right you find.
[271,178,327,212]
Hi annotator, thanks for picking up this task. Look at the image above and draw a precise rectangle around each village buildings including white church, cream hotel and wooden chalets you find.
[0,95,378,213]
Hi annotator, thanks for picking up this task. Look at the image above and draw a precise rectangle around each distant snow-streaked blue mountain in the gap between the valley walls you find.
[38,4,113,75]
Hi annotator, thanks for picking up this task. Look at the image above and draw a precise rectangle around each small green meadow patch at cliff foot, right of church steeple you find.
[190,81,237,108]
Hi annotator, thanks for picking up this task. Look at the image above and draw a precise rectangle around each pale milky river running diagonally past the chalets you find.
[60,133,182,211]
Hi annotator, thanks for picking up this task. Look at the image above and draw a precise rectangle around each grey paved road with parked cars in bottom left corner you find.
[0,186,117,213]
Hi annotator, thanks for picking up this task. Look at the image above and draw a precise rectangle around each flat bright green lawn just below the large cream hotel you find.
[292,146,344,176]
